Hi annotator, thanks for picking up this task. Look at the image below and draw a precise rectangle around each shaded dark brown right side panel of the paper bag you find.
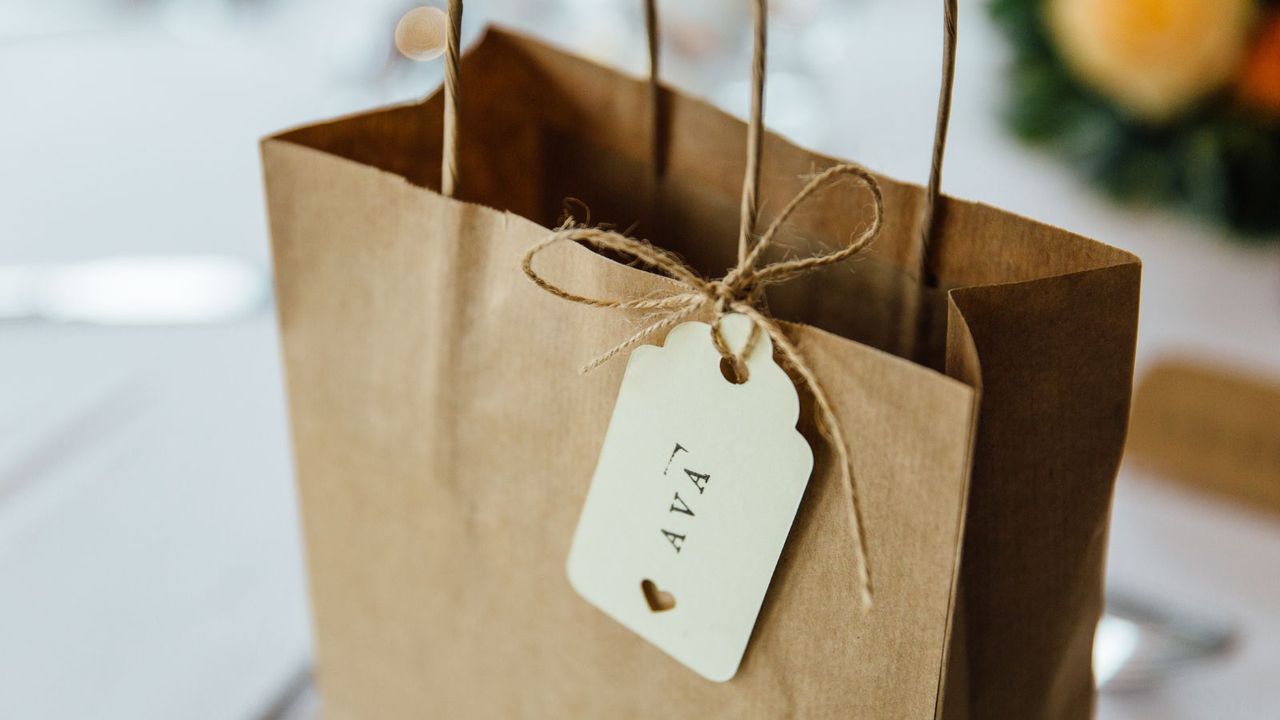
[948,262,1140,719]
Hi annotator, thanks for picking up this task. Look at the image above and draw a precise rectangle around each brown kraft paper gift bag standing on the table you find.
[262,2,1139,719]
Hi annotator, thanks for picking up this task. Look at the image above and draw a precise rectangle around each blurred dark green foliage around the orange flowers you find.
[989,0,1280,242]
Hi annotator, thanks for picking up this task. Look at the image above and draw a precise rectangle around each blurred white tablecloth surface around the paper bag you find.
[0,0,1280,720]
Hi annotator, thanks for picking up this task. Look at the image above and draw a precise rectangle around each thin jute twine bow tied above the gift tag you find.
[521,164,884,607]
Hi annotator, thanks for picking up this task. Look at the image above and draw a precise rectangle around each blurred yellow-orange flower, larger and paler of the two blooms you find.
[1046,0,1256,122]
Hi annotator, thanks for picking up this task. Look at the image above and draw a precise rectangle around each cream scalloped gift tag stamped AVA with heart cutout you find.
[568,314,813,682]
